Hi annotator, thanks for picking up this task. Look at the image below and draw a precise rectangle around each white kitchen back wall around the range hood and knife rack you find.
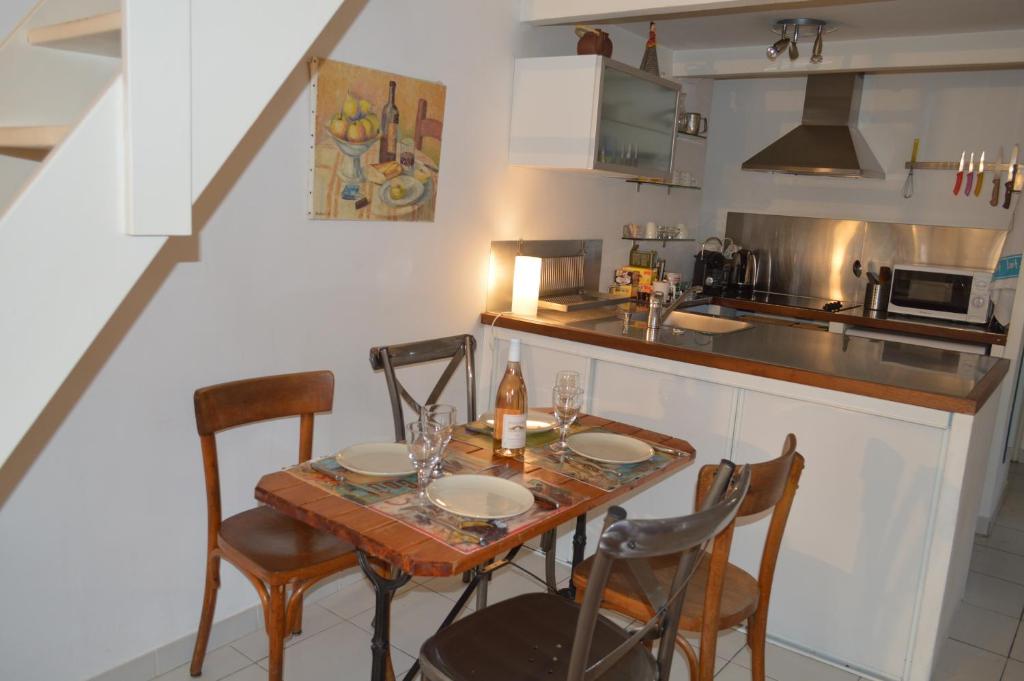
[701,70,1024,233]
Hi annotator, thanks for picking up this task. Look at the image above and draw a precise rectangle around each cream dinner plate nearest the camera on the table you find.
[427,475,534,519]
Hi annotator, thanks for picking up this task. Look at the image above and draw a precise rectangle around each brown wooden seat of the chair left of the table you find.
[218,506,355,582]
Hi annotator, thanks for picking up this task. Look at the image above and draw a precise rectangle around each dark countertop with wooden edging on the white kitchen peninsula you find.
[480,309,1010,414]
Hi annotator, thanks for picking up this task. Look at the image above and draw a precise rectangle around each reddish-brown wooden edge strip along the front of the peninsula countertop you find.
[480,312,1009,414]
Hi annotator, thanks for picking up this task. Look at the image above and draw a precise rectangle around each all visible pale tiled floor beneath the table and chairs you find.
[158,467,1024,681]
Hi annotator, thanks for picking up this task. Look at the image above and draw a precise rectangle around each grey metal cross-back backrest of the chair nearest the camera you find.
[566,461,751,681]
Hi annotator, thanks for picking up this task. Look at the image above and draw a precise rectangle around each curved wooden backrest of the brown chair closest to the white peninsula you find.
[697,433,804,678]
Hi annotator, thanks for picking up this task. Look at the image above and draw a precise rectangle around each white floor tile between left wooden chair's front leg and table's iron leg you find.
[252,622,414,681]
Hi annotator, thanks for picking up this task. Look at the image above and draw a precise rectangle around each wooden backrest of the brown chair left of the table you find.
[194,371,334,548]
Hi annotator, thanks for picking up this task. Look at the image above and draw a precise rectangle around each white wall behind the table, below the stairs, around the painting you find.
[0,0,698,681]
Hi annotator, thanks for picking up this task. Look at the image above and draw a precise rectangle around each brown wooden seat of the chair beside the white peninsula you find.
[572,553,759,632]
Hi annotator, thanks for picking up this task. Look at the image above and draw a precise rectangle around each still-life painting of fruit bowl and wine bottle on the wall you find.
[309,59,445,222]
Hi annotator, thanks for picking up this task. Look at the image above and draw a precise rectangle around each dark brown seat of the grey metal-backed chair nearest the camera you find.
[420,594,655,681]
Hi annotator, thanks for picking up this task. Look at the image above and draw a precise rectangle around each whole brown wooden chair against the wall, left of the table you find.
[189,371,355,681]
